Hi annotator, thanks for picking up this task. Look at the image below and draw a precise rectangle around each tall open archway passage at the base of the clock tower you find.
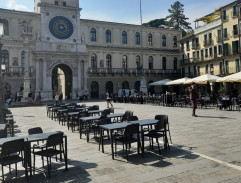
[52,64,73,99]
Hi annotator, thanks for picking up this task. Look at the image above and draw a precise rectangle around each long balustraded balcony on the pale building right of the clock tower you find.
[88,68,181,76]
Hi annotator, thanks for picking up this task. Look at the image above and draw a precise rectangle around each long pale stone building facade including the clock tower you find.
[0,0,181,100]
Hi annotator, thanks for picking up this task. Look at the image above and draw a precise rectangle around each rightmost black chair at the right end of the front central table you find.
[144,115,170,154]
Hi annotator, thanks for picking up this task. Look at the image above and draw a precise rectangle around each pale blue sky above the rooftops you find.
[0,0,233,25]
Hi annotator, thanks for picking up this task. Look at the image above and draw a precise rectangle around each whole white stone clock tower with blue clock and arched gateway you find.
[34,0,88,99]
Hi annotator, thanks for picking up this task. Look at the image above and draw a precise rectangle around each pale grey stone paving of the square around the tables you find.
[0,101,241,183]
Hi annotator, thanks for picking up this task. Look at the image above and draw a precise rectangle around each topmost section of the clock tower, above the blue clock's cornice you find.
[34,0,79,13]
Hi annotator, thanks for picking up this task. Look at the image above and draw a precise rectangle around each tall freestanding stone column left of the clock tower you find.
[22,33,32,102]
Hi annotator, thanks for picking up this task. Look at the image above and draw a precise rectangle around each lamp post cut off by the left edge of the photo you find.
[0,23,5,123]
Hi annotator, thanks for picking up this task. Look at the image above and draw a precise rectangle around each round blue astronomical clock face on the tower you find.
[49,16,73,39]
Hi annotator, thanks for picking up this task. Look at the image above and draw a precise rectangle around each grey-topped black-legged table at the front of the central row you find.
[100,119,158,159]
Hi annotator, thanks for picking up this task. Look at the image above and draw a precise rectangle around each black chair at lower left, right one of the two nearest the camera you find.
[33,132,65,177]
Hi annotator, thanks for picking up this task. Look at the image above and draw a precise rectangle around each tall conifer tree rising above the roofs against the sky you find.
[166,1,192,35]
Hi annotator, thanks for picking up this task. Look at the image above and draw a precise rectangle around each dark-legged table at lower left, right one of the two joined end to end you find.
[26,131,68,176]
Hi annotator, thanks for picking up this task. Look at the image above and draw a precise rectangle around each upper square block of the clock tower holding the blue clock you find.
[34,0,81,43]
